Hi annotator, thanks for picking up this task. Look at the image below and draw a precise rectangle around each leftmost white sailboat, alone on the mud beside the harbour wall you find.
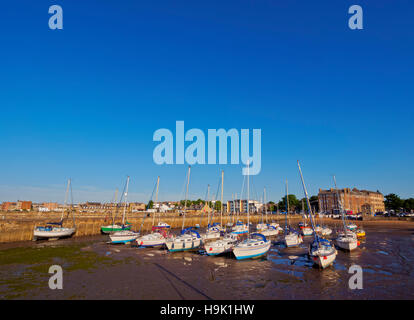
[33,179,76,241]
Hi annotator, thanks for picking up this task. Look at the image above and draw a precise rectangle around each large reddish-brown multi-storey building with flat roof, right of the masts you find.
[318,188,385,214]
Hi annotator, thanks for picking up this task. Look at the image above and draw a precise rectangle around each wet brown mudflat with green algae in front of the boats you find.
[0,221,414,300]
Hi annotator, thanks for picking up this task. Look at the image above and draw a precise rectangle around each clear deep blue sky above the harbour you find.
[0,0,414,202]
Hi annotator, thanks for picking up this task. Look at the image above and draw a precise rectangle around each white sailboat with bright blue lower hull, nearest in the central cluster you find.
[233,161,271,260]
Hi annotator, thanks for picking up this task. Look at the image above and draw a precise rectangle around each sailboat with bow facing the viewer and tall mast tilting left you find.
[298,160,338,269]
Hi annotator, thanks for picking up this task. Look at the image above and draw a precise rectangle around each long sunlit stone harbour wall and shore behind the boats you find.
[0,212,414,243]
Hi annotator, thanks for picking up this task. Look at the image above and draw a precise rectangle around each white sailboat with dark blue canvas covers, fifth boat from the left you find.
[165,166,202,252]
